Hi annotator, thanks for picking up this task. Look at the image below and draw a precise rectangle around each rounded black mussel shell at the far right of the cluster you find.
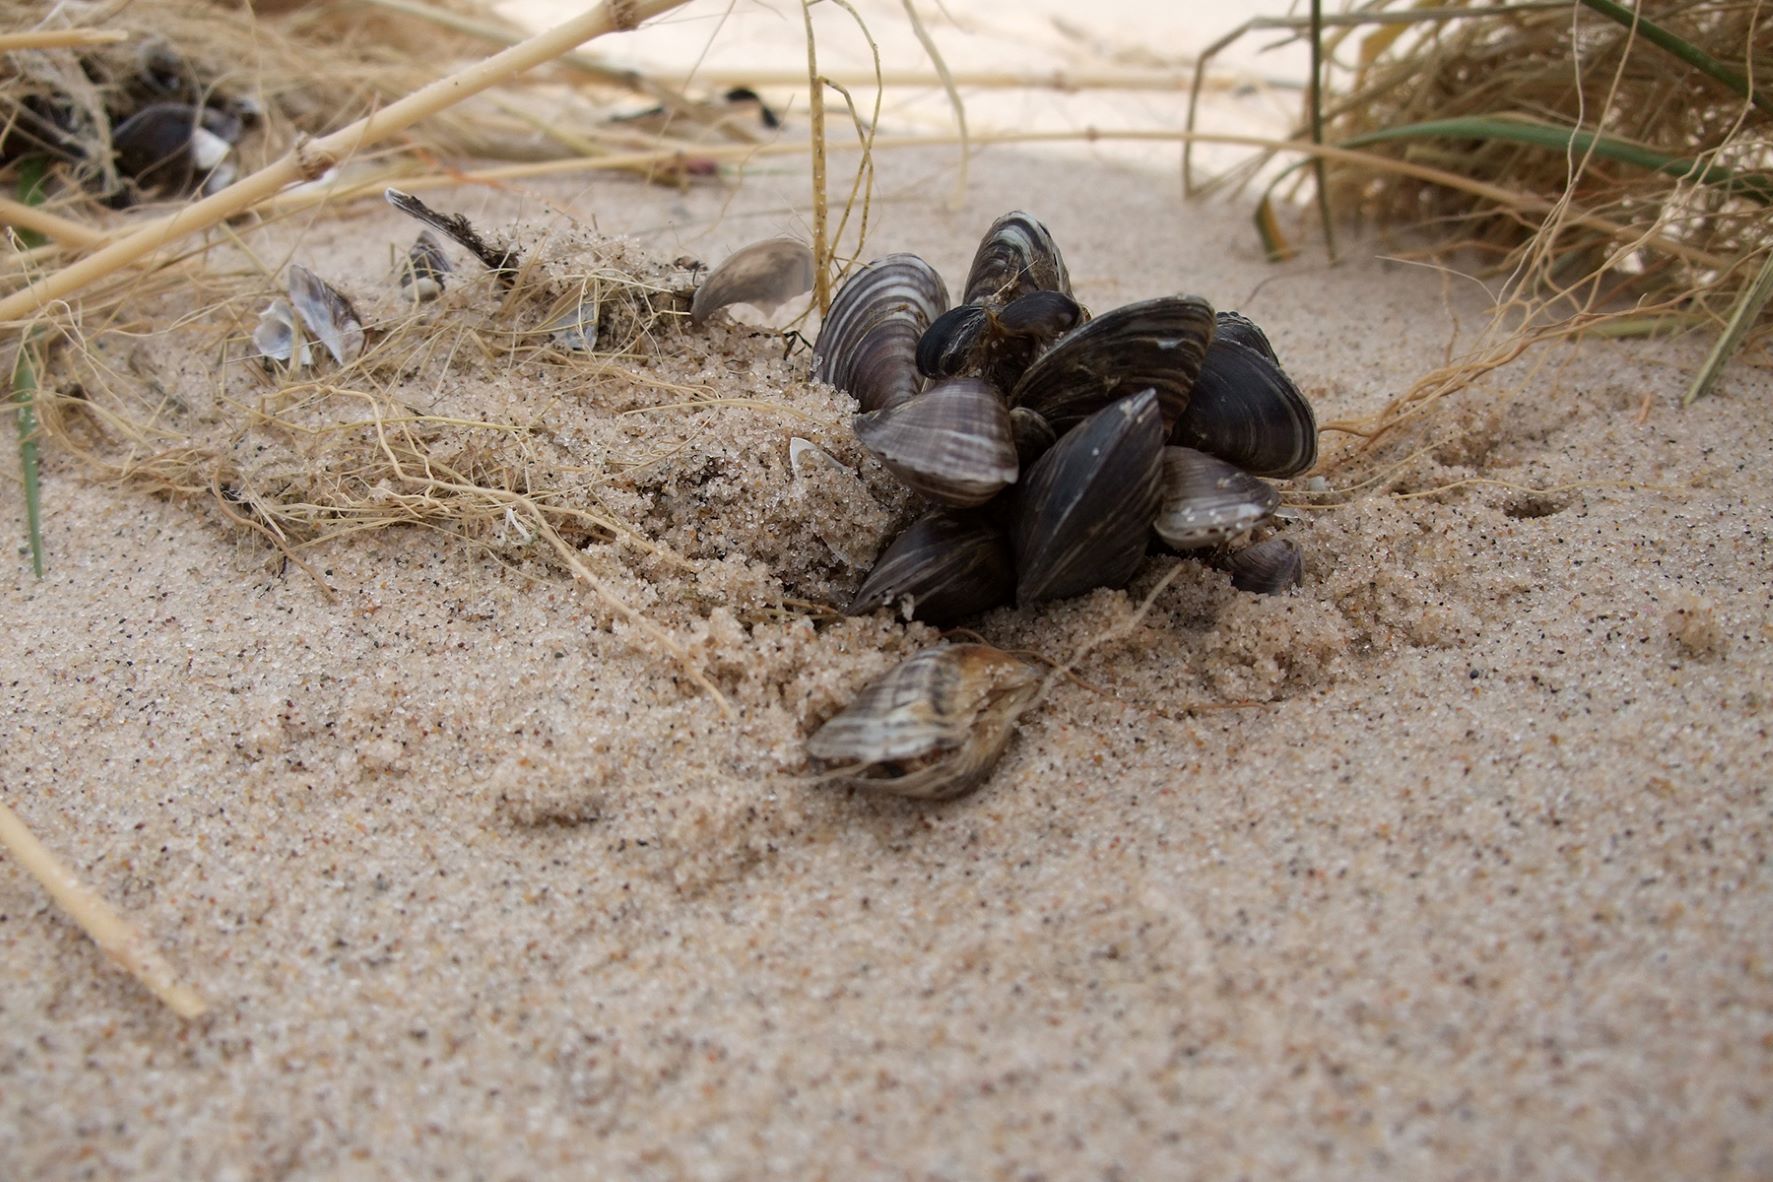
[1170,317,1317,478]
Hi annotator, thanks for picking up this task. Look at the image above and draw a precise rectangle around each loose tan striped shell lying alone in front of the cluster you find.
[807,645,1041,801]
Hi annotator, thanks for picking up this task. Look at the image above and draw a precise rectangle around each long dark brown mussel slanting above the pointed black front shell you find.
[1009,296,1213,431]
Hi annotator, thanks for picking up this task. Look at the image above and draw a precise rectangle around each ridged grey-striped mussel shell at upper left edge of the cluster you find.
[812,253,949,411]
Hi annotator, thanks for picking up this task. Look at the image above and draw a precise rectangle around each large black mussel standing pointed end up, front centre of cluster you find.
[1011,390,1163,604]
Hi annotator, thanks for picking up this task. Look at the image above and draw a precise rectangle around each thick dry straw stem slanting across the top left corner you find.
[0,0,688,323]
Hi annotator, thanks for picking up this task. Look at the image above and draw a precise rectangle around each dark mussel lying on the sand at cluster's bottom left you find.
[844,510,1016,627]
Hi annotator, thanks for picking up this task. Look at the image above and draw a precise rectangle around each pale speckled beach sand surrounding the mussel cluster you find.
[0,27,1773,1178]
